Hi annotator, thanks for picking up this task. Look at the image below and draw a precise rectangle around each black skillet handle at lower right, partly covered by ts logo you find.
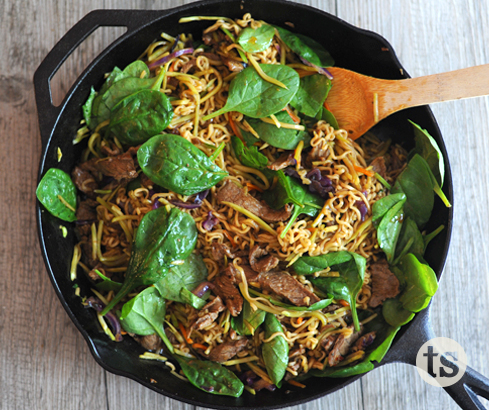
[385,307,489,410]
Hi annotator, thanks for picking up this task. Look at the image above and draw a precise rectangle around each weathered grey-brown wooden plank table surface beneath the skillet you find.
[0,0,489,410]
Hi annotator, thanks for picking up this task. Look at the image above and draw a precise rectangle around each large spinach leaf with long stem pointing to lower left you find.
[102,207,197,315]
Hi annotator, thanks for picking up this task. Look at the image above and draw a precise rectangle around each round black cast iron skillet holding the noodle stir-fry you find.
[34,0,489,409]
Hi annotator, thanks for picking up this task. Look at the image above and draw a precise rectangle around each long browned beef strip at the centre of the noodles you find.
[217,181,291,222]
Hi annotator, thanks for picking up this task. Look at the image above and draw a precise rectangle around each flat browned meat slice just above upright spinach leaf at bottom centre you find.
[258,272,321,306]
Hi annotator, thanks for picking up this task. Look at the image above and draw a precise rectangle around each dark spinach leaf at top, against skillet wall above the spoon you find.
[274,26,334,67]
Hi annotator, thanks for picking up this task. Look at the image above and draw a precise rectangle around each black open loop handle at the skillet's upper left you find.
[34,10,168,149]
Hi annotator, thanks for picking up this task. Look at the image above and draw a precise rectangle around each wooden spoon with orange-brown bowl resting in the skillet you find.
[326,64,489,139]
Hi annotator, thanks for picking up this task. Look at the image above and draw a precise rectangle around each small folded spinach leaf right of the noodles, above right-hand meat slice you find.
[377,200,405,263]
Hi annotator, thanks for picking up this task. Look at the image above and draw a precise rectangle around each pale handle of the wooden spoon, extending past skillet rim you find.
[382,64,489,120]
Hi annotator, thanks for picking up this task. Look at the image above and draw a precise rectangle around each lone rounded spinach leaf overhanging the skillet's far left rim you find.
[36,168,76,222]
